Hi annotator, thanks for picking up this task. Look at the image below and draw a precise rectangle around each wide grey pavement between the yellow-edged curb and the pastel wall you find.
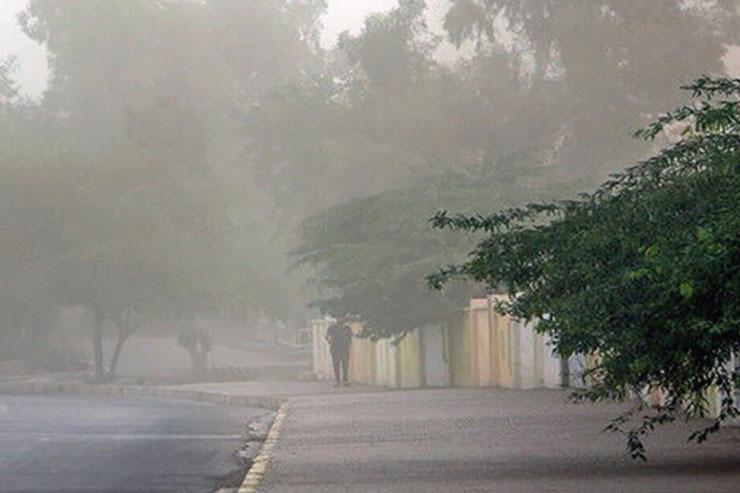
[260,389,740,493]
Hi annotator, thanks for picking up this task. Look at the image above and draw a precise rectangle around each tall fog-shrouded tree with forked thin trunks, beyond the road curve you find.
[9,0,323,377]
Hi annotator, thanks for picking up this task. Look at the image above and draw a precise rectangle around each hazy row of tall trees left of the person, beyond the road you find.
[0,0,322,379]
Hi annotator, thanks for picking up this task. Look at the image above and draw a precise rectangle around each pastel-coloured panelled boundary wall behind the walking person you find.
[311,296,586,389]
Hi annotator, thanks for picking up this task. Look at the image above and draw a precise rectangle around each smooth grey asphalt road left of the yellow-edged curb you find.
[0,396,264,492]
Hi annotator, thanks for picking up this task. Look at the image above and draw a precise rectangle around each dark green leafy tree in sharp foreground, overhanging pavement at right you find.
[429,77,740,458]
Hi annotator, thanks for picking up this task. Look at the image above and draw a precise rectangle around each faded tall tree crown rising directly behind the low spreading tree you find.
[248,1,444,215]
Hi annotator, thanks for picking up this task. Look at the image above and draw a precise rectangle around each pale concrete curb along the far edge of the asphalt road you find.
[0,381,287,411]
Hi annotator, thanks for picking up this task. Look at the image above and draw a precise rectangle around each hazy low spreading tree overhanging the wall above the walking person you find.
[293,152,564,338]
